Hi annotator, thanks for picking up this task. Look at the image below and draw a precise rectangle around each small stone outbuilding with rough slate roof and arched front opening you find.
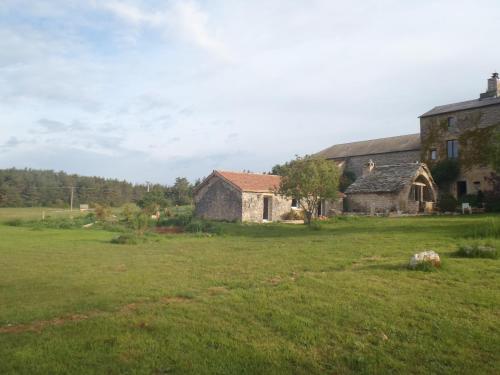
[346,161,437,214]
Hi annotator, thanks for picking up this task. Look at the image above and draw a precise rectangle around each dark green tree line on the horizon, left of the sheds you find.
[0,168,194,208]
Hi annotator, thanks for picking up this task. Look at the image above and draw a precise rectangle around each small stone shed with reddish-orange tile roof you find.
[194,171,292,222]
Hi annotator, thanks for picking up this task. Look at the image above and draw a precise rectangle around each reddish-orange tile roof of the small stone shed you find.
[214,171,281,193]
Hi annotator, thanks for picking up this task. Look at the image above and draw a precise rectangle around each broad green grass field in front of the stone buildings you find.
[0,210,500,374]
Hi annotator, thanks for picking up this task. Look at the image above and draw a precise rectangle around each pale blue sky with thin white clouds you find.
[0,0,500,184]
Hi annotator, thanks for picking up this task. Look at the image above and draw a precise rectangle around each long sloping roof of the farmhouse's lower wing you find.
[316,133,420,159]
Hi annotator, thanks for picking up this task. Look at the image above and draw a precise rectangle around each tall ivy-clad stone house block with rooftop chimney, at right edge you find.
[420,72,500,197]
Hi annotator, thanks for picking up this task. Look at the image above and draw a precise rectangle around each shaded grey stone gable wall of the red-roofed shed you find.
[195,177,242,221]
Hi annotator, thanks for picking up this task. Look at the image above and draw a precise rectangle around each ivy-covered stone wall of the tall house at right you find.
[420,105,500,196]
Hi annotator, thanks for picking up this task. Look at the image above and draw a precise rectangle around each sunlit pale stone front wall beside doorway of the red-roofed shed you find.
[242,192,292,223]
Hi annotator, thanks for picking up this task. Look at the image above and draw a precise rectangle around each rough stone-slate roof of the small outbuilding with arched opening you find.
[346,163,423,194]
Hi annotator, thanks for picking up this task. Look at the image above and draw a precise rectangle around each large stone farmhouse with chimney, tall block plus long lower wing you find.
[316,73,500,207]
